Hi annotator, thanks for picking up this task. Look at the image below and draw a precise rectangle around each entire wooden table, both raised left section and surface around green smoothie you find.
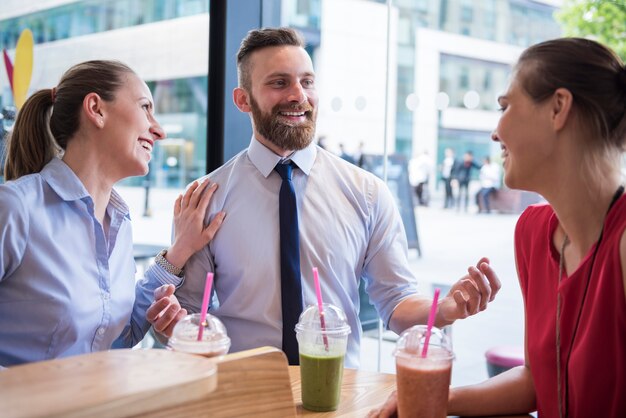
[0,347,532,418]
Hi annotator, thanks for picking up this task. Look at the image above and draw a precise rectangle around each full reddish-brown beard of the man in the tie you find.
[250,95,317,151]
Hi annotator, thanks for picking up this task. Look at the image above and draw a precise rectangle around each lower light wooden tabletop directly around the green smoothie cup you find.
[289,366,396,417]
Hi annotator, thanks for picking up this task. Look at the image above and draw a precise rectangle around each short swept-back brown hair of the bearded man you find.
[237,28,305,91]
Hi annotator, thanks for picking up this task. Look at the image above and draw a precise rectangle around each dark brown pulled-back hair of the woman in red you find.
[516,38,626,149]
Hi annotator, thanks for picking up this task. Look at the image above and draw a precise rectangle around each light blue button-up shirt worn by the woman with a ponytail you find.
[0,158,181,367]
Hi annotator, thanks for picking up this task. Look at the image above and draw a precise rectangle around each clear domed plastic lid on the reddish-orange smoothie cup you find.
[394,325,454,358]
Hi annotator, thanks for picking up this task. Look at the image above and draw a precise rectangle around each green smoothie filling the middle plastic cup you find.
[300,353,344,412]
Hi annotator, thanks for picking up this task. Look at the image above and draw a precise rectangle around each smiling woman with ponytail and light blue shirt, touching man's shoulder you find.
[0,61,224,367]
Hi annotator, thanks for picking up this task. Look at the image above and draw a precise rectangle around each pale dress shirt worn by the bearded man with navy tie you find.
[176,138,416,367]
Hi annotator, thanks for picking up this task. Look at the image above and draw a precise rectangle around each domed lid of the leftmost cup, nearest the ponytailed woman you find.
[168,313,230,353]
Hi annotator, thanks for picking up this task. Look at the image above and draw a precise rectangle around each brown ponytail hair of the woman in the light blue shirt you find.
[4,61,134,181]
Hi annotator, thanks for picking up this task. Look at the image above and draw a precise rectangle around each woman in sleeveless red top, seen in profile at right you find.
[371,38,626,417]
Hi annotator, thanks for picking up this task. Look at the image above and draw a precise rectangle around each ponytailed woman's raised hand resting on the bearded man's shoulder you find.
[167,179,226,267]
